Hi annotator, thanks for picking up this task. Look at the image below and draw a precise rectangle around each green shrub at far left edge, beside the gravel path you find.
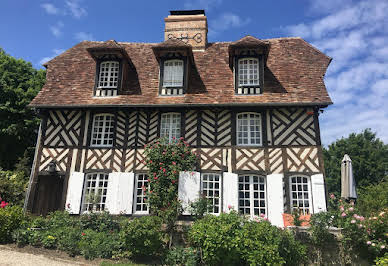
[0,206,25,243]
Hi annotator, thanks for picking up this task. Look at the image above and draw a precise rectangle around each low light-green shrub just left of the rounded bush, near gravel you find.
[78,229,119,259]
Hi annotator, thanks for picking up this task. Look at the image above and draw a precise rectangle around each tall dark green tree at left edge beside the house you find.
[0,48,46,169]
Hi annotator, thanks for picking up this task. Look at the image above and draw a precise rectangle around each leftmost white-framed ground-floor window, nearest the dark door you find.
[81,172,109,213]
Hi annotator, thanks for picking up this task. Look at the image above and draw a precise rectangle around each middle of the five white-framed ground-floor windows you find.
[201,173,222,215]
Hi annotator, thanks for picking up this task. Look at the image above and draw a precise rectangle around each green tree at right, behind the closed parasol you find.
[323,129,388,195]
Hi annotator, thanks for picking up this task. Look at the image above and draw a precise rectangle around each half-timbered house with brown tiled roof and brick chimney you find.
[26,10,332,226]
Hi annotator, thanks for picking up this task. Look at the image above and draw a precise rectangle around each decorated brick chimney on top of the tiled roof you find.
[164,10,207,50]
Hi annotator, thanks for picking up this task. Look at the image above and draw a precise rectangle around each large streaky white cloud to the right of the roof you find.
[285,0,388,144]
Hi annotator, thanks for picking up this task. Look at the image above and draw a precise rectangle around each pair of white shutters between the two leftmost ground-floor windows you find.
[105,172,135,214]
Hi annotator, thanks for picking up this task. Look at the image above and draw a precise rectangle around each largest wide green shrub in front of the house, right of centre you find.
[189,211,305,265]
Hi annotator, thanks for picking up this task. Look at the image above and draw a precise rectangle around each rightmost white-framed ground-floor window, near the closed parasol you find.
[289,175,313,215]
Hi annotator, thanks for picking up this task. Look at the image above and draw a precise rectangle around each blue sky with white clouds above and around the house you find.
[0,0,388,144]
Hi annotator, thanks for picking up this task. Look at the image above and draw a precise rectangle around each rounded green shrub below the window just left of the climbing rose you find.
[120,216,165,258]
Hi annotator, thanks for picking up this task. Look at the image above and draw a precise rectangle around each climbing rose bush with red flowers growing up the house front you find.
[143,138,197,225]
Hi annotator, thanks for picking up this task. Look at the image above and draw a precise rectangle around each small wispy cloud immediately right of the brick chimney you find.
[209,13,252,37]
